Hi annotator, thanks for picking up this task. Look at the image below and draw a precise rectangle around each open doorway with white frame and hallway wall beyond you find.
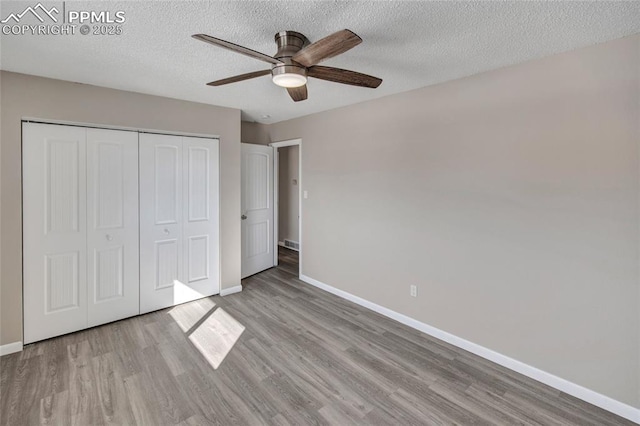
[270,139,303,277]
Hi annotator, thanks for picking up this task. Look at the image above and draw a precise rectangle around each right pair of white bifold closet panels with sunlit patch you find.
[140,133,220,313]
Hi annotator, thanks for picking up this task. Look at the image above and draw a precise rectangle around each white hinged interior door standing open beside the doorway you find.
[241,143,274,278]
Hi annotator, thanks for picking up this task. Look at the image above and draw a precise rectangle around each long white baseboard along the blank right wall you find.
[300,275,640,424]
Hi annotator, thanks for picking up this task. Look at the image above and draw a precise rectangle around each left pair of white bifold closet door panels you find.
[22,123,139,343]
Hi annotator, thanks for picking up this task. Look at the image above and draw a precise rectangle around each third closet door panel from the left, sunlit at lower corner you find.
[139,133,186,313]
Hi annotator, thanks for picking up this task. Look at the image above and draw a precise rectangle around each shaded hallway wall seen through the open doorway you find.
[278,145,300,242]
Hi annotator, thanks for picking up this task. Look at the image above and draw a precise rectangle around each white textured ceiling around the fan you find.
[0,1,640,123]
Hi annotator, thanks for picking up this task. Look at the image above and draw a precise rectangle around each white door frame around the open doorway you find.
[269,138,303,278]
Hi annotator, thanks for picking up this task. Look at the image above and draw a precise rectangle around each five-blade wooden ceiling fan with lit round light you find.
[192,30,382,102]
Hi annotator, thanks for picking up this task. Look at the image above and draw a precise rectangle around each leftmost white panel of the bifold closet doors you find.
[22,123,87,344]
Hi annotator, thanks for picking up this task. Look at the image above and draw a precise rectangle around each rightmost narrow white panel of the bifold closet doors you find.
[183,137,220,297]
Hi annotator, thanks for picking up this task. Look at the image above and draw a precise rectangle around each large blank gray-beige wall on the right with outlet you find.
[270,36,640,407]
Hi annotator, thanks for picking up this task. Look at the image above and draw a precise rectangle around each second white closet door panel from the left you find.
[87,129,140,327]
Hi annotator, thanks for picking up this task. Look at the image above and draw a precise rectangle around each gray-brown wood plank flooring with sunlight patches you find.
[0,249,632,426]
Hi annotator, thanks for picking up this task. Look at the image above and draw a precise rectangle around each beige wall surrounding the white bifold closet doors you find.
[0,71,240,345]
